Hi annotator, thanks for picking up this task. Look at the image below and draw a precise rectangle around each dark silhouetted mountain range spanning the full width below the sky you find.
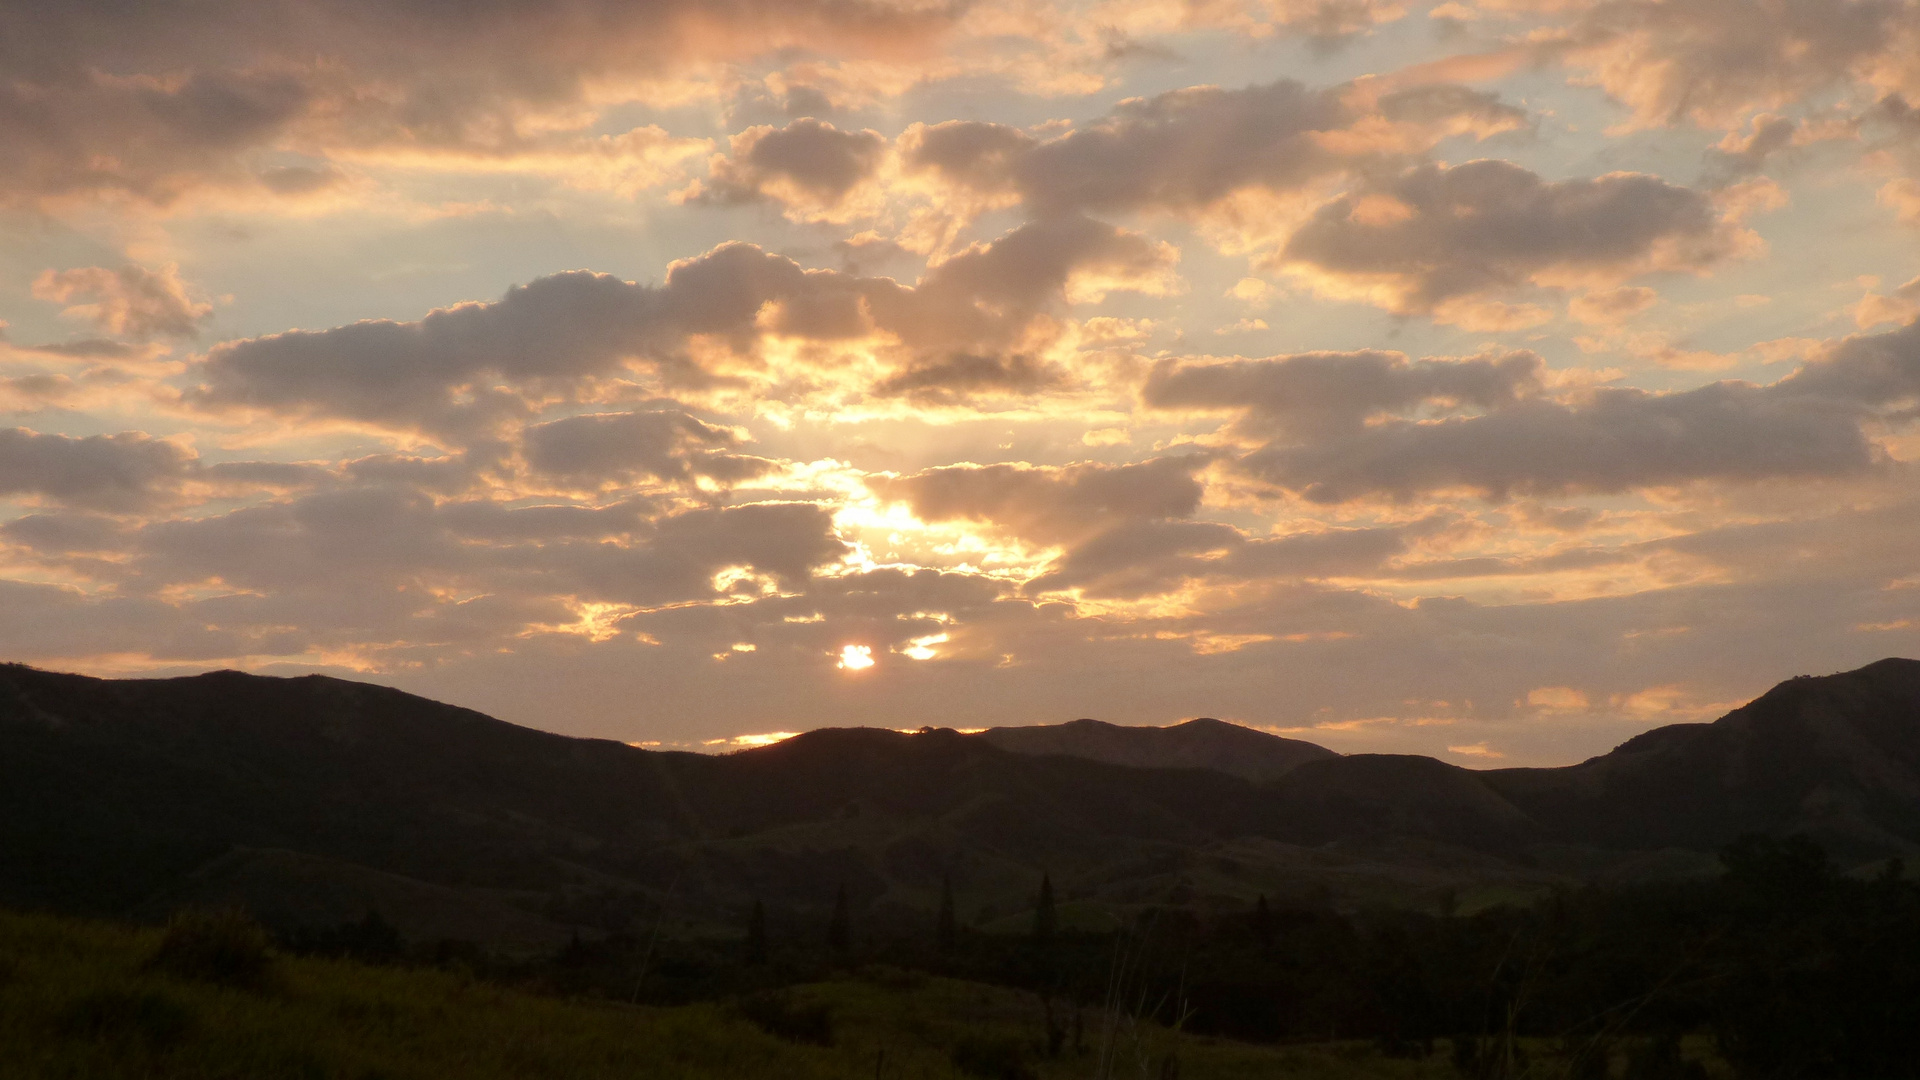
[0,659,1920,944]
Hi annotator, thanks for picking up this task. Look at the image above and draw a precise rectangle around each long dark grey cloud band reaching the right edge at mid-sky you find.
[1182,323,1920,503]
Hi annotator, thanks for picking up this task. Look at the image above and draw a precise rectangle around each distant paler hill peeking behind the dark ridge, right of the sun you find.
[975,717,1338,780]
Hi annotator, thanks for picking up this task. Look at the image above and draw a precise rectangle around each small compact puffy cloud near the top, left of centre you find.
[684,117,887,219]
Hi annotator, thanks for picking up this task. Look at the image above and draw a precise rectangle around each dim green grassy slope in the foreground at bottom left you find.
[0,913,1489,1080]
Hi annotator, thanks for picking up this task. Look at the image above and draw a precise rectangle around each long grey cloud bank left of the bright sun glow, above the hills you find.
[125,476,847,611]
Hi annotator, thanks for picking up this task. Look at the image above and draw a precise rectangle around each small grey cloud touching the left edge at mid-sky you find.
[0,427,196,509]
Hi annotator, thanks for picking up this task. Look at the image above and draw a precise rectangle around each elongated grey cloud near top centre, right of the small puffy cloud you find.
[902,79,1526,213]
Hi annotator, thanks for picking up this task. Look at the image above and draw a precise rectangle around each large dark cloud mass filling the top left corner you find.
[0,0,964,202]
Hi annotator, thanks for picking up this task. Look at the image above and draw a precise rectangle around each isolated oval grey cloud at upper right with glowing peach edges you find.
[1277,160,1757,317]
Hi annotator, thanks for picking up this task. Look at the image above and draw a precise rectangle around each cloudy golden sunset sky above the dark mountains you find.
[0,0,1920,767]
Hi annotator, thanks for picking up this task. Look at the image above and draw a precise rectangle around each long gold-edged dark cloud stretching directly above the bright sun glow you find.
[188,217,1175,440]
